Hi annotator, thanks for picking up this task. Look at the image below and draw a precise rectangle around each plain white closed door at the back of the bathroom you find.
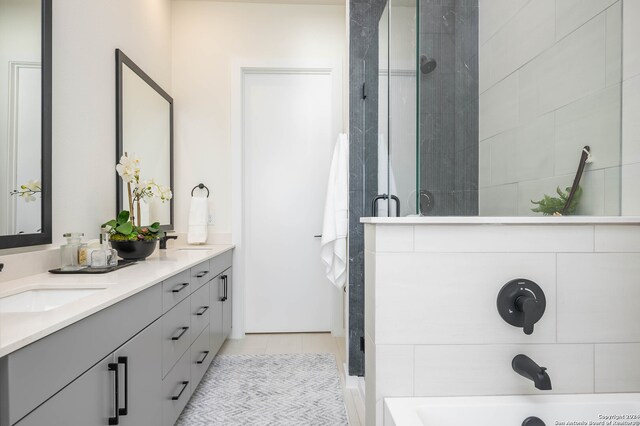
[242,70,339,333]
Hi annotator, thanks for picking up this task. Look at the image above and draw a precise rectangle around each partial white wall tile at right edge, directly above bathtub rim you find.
[595,343,640,392]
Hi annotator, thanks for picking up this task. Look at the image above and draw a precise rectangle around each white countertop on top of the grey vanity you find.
[0,245,233,358]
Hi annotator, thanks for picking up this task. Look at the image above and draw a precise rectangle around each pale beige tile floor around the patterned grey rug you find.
[220,333,365,426]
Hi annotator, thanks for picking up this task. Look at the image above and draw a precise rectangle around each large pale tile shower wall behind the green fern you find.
[479,0,624,216]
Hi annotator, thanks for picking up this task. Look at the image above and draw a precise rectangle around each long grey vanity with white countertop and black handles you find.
[0,246,233,426]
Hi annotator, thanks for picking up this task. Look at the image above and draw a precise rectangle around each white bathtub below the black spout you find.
[384,393,640,426]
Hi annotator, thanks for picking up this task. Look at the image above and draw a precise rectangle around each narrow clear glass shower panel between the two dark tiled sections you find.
[379,0,418,216]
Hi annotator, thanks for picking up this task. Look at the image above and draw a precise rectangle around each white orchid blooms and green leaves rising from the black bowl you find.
[103,153,173,241]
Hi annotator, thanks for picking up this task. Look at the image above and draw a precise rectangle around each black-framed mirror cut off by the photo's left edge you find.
[0,0,52,249]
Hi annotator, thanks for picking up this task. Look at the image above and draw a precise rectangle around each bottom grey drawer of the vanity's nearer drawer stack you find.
[162,351,192,426]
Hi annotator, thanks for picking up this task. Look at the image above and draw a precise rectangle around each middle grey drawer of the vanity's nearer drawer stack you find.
[162,299,191,377]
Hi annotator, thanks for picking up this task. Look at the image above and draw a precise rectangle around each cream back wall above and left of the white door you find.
[172,1,347,242]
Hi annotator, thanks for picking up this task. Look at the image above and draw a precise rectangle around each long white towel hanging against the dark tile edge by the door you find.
[320,134,349,288]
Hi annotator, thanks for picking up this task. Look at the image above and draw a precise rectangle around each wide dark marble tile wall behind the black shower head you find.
[419,0,479,216]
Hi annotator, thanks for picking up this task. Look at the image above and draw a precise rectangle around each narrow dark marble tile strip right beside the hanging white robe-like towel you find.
[348,0,386,376]
